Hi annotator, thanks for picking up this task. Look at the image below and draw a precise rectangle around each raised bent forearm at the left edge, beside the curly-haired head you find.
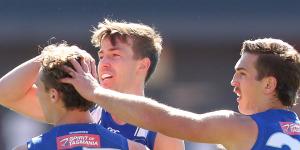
[0,57,40,104]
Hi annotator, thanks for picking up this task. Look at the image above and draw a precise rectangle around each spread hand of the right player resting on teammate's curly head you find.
[60,59,101,101]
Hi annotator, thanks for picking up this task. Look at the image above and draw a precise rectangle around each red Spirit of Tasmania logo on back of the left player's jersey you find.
[56,134,101,150]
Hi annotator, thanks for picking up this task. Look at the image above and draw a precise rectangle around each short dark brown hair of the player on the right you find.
[241,38,300,107]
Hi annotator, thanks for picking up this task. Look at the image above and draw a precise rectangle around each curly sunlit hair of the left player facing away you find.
[41,43,94,111]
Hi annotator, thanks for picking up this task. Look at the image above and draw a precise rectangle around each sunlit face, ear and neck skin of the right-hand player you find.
[231,53,284,115]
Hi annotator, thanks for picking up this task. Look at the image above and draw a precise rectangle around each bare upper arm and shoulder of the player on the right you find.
[189,110,258,149]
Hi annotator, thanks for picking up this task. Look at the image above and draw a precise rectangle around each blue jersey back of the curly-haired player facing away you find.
[27,124,128,150]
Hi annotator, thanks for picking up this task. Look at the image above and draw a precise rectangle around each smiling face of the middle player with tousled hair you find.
[98,38,139,92]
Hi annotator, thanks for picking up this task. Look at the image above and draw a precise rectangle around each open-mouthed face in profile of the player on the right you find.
[231,53,263,115]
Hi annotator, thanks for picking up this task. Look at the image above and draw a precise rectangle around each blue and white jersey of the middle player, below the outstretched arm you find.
[91,107,156,150]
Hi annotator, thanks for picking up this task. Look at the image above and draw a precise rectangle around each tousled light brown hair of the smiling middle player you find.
[91,19,162,82]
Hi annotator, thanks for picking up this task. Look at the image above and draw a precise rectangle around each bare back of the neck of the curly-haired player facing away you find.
[54,110,93,125]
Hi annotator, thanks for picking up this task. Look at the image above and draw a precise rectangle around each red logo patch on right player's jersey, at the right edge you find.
[279,122,300,135]
